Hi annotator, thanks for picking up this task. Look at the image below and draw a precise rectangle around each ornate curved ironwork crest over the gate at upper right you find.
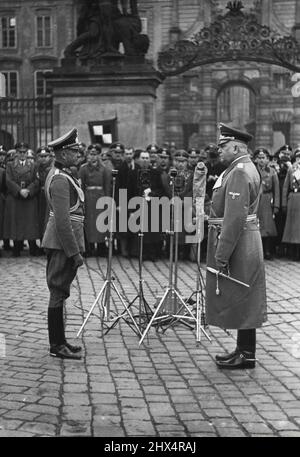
[158,1,300,76]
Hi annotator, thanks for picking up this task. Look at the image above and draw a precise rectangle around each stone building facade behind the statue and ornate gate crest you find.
[0,0,300,152]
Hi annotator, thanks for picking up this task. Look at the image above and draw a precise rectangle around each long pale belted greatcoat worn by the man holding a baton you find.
[206,155,266,329]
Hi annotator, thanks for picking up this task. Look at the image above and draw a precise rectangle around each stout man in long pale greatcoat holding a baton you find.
[206,124,267,369]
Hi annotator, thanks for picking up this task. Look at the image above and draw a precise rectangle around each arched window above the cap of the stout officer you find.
[217,83,255,129]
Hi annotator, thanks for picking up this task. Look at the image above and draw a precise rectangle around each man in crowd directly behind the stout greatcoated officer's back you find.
[254,147,280,260]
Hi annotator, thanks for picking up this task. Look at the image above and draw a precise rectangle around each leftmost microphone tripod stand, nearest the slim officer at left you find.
[77,170,141,337]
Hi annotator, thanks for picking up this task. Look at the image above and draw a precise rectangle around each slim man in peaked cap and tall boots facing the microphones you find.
[42,128,85,359]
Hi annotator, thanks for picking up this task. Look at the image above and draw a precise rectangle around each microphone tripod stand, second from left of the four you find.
[105,187,153,336]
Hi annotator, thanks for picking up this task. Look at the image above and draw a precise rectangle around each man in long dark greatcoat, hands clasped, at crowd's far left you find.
[4,143,40,257]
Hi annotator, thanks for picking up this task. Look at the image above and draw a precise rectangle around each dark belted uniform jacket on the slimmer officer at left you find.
[42,167,85,257]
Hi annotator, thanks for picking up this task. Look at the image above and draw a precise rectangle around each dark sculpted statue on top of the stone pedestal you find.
[64,0,149,59]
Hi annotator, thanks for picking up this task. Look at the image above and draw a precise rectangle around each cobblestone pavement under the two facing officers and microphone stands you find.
[0,254,300,437]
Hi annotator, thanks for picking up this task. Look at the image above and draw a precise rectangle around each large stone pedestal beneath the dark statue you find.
[49,56,163,148]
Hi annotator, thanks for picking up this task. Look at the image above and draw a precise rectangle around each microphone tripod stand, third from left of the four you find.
[139,169,195,344]
